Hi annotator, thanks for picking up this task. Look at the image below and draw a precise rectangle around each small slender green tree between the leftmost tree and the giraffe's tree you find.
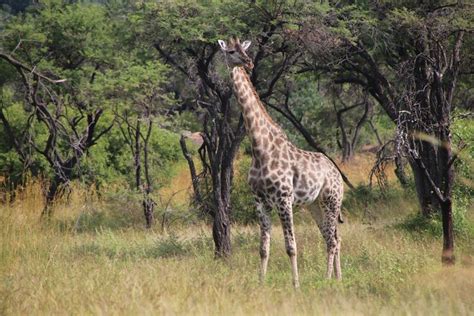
[105,59,171,228]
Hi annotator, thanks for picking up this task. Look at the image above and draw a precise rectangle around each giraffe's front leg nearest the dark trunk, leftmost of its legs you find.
[257,200,272,283]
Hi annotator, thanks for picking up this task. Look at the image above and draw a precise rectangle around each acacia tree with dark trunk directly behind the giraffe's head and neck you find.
[144,1,308,257]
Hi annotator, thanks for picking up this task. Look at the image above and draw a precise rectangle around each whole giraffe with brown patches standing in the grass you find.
[218,39,344,288]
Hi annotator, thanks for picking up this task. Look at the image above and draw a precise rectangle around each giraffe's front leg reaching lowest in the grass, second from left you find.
[278,198,300,288]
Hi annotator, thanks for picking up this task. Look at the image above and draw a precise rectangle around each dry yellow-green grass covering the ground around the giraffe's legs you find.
[0,159,474,315]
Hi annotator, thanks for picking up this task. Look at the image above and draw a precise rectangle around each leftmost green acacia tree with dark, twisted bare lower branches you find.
[0,2,113,214]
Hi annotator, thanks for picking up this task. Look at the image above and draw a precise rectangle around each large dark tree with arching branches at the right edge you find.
[297,1,473,263]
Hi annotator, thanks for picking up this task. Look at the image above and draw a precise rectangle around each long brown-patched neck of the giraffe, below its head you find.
[232,67,287,149]
